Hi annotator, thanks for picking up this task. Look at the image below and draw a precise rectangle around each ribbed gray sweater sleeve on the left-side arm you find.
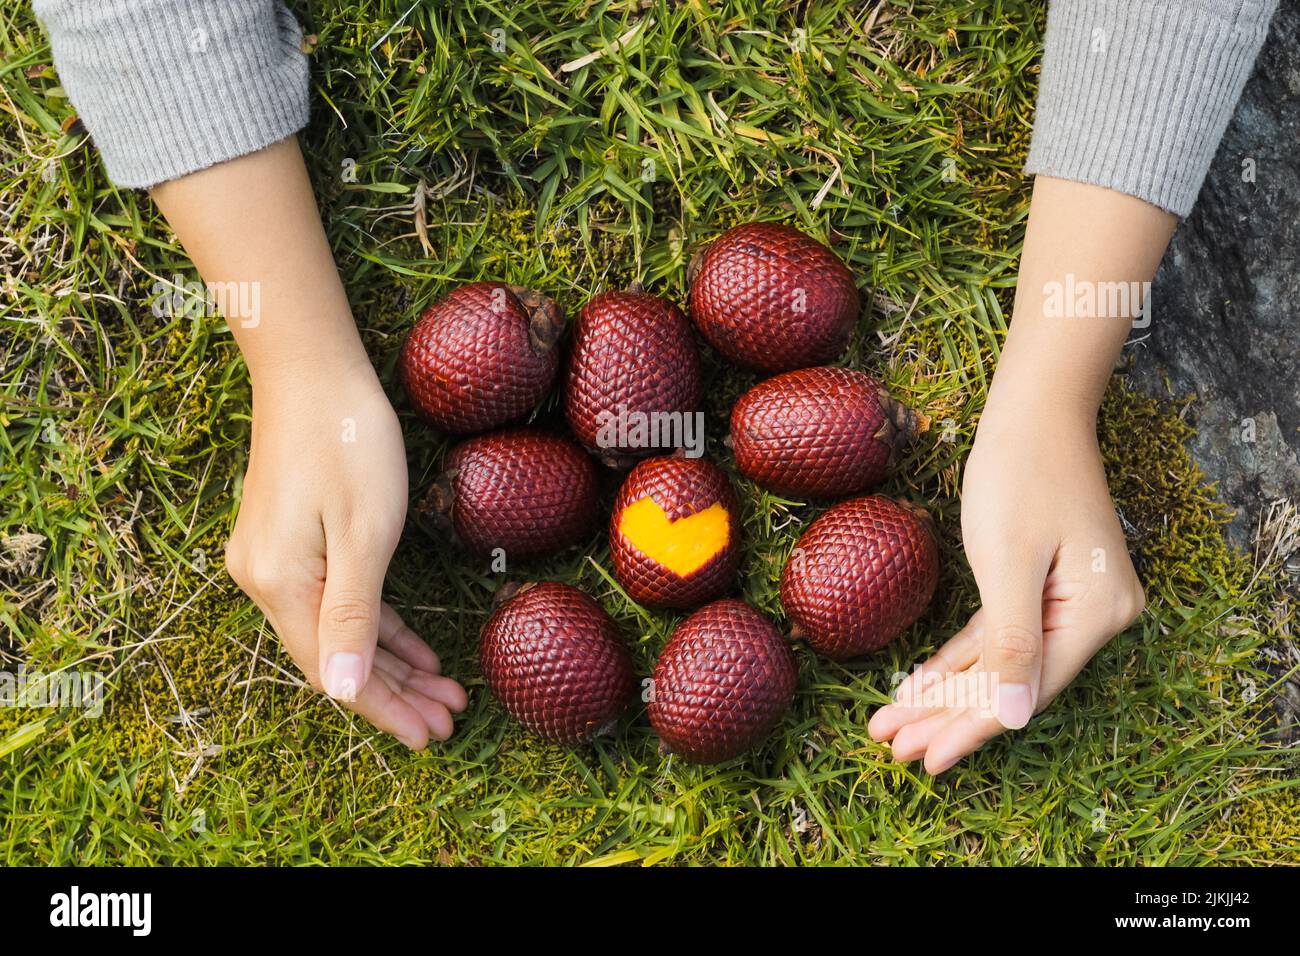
[33,0,308,187]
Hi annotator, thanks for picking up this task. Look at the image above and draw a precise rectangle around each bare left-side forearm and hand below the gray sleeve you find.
[152,138,465,749]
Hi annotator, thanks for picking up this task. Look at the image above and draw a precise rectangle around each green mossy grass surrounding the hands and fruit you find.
[0,0,1300,865]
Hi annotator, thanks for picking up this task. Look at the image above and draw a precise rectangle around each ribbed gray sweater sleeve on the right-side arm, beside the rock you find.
[1024,0,1278,216]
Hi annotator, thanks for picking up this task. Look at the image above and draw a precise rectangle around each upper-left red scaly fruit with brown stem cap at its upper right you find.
[399,282,564,434]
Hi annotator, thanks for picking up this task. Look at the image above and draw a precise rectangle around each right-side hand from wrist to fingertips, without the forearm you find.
[868,377,1144,774]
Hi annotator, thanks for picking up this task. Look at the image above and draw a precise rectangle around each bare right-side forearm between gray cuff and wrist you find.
[989,176,1177,429]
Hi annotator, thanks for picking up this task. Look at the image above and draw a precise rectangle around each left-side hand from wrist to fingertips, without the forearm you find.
[226,350,467,749]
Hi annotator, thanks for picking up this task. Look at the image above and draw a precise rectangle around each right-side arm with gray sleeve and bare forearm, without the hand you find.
[1003,0,1277,421]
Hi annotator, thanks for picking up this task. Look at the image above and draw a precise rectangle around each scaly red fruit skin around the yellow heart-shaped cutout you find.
[610,454,740,609]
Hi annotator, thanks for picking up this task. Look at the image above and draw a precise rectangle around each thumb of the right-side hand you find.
[976,555,1048,730]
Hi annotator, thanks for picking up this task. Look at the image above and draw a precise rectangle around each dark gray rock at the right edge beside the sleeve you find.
[1128,0,1300,554]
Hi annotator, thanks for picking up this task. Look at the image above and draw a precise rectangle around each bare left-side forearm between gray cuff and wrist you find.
[152,137,373,388]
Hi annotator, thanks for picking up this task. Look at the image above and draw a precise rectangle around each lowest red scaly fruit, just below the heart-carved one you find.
[646,598,798,763]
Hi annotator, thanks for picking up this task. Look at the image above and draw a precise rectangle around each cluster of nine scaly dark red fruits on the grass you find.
[400,222,939,762]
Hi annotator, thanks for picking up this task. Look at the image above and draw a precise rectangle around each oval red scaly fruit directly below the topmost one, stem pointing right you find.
[729,367,918,498]
